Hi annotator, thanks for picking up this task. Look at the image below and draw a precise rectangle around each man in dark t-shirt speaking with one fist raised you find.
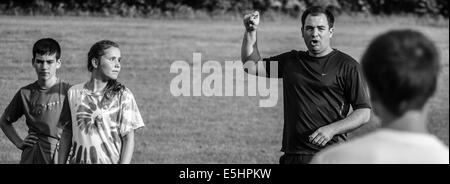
[241,6,371,164]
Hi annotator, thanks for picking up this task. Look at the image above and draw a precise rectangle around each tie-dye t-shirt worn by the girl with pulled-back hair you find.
[68,83,144,164]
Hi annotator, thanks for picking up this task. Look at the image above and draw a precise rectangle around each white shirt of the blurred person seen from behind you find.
[311,128,449,164]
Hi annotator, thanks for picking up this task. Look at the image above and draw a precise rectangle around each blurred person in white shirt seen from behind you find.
[312,30,449,164]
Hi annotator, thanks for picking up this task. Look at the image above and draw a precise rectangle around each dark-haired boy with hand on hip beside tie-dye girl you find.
[0,38,70,164]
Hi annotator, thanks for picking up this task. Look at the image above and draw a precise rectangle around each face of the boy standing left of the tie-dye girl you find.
[32,53,61,81]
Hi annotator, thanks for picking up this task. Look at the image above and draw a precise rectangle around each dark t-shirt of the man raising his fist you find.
[263,49,370,154]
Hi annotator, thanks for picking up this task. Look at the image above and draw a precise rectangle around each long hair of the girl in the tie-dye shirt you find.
[87,40,125,99]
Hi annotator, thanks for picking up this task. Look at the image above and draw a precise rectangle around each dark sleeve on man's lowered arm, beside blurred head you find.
[346,64,371,109]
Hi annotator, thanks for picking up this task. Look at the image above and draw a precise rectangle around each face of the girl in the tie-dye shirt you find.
[98,47,121,80]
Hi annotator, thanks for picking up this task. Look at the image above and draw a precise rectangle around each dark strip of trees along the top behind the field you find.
[0,0,448,18]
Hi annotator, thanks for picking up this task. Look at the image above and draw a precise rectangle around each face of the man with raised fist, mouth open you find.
[302,13,333,56]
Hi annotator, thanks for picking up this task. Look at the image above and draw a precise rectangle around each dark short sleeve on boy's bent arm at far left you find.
[3,90,24,123]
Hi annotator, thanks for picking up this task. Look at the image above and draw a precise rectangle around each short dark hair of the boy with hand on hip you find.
[33,38,61,59]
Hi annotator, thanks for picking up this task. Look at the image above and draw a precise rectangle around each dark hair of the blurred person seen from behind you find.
[361,30,440,116]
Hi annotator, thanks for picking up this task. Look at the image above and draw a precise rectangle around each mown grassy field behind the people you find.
[0,16,449,164]
